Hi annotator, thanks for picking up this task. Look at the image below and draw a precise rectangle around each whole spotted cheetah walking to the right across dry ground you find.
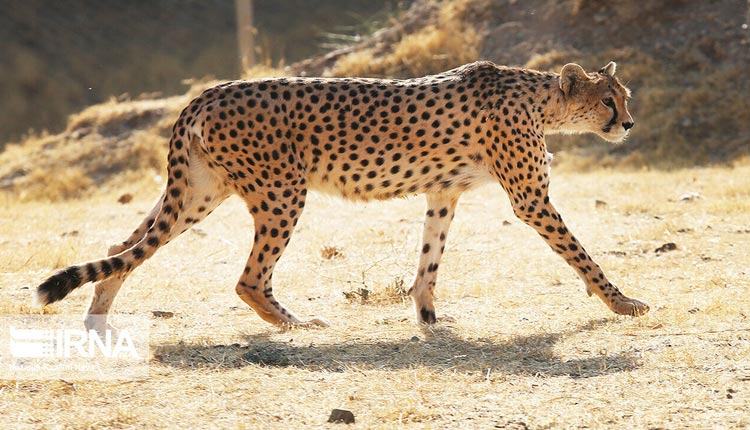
[36,61,649,329]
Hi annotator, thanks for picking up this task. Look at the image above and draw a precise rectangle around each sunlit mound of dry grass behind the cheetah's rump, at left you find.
[0,60,296,201]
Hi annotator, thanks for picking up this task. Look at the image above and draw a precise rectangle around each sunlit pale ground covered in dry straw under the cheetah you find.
[0,166,750,429]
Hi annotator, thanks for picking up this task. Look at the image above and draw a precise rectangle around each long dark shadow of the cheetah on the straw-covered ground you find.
[154,319,640,378]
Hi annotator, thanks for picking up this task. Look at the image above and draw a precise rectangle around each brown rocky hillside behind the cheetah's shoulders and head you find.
[292,0,750,167]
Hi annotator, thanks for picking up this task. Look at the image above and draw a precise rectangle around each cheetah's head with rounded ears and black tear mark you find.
[560,61,634,142]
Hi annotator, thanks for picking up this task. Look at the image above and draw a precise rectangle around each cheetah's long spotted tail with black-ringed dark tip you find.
[35,101,195,306]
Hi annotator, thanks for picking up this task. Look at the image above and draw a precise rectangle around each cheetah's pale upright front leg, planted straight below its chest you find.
[409,194,458,324]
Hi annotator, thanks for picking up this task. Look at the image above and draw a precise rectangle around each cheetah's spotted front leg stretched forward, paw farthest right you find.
[511,187,649,316]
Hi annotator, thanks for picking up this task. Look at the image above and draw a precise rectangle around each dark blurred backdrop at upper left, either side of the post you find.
[0,0,408,144]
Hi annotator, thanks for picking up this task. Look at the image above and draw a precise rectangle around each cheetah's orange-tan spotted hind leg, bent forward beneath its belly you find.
[235,187,329,328]
